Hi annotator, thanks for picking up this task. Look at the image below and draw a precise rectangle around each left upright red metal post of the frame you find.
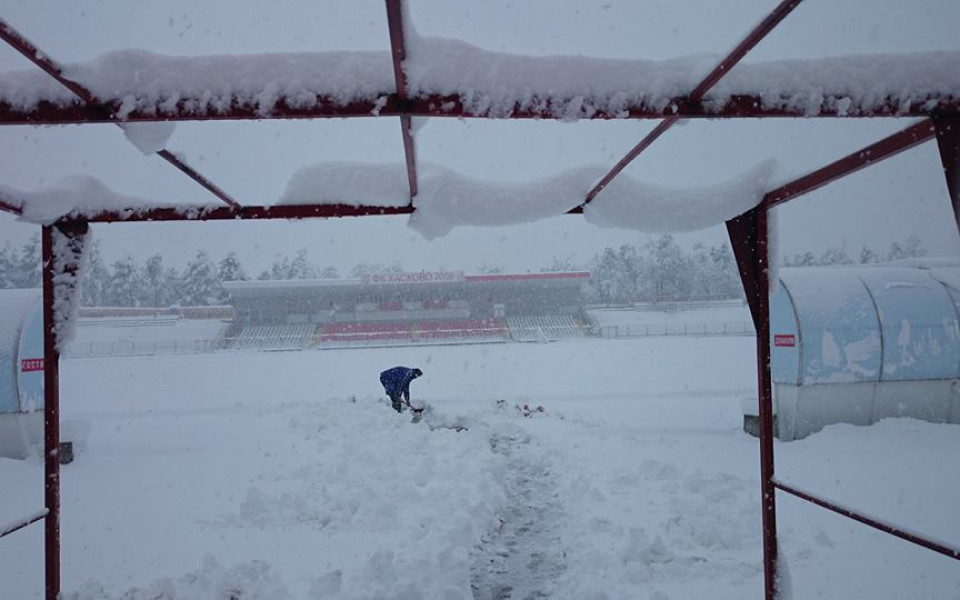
[41,225,60,600]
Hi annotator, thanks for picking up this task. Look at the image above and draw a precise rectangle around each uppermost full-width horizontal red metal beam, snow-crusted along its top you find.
[0,95,960,125]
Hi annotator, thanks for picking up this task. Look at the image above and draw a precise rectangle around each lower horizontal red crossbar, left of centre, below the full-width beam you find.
[63,204,414,223]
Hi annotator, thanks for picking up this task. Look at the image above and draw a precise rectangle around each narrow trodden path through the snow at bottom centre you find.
[471,432,567,600]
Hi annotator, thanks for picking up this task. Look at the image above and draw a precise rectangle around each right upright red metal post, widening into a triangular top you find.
[727,207,777,600]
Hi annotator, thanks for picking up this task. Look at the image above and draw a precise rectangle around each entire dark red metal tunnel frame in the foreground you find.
[0,0,960,600]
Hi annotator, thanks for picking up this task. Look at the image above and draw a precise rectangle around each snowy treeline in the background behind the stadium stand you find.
[0,235,927,306]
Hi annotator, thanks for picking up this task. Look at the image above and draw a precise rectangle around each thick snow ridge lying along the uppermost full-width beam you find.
[0,42,960,120]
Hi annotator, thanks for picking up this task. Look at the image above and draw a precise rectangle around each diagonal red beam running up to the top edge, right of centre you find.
[583,0,801,204]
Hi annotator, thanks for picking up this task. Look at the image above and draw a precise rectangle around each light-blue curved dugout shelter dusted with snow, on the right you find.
[770,259,960,440]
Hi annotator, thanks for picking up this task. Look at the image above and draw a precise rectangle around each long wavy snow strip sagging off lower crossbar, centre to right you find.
[280,161,775,239]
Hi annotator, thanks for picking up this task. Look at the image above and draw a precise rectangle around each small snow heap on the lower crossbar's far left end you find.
[0,175,216,225]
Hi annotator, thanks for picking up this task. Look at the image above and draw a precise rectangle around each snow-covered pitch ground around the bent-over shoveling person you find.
[0,337,960,600]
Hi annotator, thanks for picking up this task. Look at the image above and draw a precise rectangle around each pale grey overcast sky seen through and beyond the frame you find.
[0,0,960,275]
